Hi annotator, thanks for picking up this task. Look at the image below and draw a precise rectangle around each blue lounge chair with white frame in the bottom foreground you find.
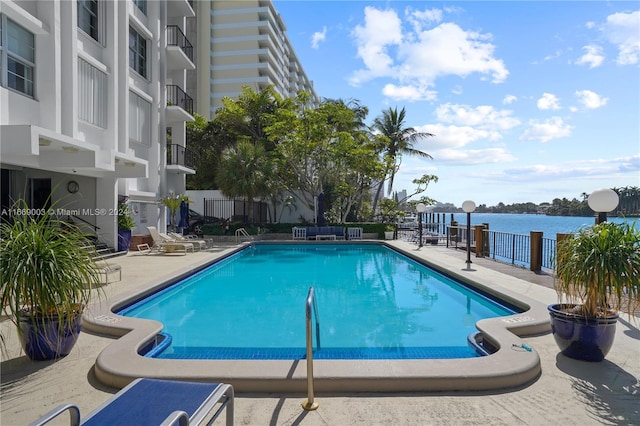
[31,378,234,426]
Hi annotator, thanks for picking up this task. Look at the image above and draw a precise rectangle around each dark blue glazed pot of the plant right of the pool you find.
[547,304,618,362]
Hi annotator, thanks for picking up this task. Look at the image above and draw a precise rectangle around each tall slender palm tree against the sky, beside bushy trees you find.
[372,107,434,212]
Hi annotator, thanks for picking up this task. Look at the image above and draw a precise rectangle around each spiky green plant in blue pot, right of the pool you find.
[548,222,640,361]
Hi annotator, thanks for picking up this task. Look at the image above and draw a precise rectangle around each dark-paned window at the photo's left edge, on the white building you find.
[0,15,36,97]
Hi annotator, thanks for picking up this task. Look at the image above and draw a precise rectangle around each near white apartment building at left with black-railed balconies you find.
[0,0,195,247]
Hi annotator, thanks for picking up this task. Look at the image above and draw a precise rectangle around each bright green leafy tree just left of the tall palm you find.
[267,92,379,220]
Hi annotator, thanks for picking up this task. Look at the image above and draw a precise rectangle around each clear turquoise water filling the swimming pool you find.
[119,244,516,359]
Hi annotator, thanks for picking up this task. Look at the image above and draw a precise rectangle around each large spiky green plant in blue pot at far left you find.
[0,200,100,360]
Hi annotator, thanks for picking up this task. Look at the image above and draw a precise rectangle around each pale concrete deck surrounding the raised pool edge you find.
[0,241,640,426]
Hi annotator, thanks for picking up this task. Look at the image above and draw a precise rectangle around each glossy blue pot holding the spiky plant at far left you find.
[18,313,82,361]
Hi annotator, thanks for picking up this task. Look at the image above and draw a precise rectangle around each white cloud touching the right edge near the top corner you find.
[601,11,640,65]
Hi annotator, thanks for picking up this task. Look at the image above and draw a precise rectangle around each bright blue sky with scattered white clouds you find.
[273,0,640,206]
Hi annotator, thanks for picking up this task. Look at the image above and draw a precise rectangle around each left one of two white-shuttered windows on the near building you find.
[78,58,107,129]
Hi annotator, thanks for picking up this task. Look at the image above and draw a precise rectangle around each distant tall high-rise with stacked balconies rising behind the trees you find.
[189,0,319,119]
